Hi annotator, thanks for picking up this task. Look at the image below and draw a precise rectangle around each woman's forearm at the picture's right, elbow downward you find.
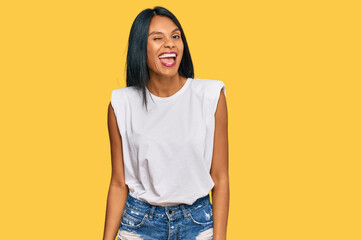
[212,178,230,240]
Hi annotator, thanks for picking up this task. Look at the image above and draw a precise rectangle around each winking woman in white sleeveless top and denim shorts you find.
[103,7,229,240]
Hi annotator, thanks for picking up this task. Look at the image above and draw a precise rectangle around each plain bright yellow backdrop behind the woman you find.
[0,0,361,240]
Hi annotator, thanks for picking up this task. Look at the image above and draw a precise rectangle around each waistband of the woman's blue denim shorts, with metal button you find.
[125,194,211,219]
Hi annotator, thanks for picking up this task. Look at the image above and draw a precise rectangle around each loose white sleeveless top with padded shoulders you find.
[111,78,226,206]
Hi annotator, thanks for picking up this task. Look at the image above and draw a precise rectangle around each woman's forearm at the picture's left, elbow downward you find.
[103,183,129,240]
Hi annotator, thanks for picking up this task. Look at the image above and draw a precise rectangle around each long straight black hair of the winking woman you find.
[126,6,194,108]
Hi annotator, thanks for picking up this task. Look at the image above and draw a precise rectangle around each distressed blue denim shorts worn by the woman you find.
[117,194,213,240]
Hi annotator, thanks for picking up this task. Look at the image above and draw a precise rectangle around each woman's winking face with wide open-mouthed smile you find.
[147,15,184,77]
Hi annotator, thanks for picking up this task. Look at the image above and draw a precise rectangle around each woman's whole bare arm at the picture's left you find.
[103,104,129,240]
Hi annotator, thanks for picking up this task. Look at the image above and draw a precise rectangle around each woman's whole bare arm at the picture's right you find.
[211,90,230,240]
